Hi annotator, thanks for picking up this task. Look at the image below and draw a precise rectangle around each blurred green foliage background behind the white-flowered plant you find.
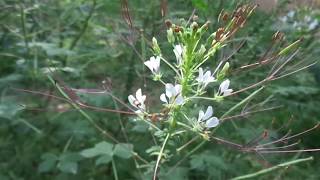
[0,0,320,180]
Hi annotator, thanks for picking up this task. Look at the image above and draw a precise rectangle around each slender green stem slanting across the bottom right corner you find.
[232,157,313,180]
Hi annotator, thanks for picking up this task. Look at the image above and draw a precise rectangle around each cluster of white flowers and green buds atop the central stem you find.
[128,17,238,134]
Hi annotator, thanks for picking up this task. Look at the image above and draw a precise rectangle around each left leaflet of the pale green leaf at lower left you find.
[80,141,113,158]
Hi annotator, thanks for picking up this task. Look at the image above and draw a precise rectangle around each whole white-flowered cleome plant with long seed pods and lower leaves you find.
[17,4,320,180]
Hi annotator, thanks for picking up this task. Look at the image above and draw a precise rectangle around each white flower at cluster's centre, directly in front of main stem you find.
[160,83,184,105]
